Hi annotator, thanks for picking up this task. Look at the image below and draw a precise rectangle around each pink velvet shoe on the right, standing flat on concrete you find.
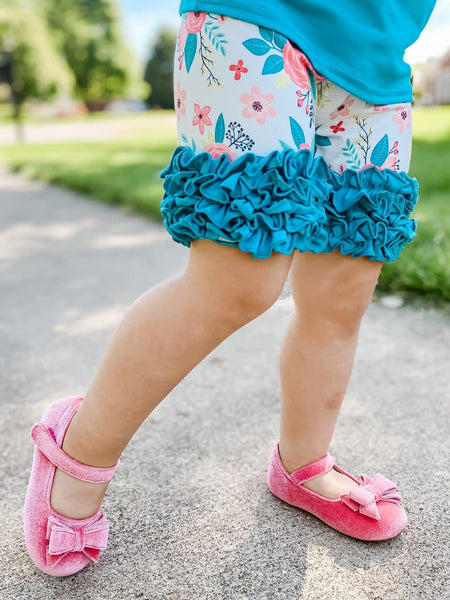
[268,444,407,541]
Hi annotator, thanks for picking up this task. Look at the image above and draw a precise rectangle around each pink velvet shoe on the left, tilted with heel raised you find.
[24,397,119,576]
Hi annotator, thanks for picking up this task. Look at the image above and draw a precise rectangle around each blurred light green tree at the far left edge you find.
[0,3,73,137]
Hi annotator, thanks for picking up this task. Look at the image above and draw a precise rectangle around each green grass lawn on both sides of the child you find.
[0,106,450,302]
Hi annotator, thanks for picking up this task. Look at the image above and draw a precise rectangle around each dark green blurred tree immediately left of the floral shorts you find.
[144,29,177,108]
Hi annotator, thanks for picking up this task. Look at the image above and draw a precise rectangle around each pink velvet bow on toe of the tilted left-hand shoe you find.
[46,514,109,566]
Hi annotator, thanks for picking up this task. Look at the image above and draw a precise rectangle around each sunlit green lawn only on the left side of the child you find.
[0,111,176,219]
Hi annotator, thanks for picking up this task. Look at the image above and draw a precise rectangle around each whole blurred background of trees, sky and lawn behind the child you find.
[0,0,450,302]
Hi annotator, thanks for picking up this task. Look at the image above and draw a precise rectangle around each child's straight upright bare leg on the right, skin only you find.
[280,251,382,498]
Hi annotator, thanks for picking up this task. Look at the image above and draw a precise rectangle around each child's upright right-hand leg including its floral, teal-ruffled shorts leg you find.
[280,80,414,497]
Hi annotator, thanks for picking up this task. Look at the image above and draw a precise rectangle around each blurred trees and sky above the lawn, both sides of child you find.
[0,0,450,123]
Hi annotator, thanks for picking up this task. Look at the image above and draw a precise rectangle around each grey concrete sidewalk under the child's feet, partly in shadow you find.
[0,174,450,600]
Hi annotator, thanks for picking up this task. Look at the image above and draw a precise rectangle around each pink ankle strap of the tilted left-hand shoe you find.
[31,423,120,483]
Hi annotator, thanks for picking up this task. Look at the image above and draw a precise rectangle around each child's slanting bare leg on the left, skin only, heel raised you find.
[51,240,292,518]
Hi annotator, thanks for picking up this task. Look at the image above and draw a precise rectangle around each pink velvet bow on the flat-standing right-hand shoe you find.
[341,473,402,521]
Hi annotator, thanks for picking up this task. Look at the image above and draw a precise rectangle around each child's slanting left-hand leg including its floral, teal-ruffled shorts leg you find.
[52,13,320,518]
